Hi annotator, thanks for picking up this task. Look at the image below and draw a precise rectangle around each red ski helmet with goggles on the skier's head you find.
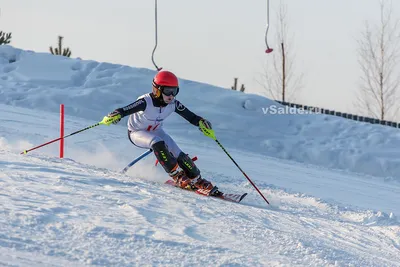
[153,70,179,97]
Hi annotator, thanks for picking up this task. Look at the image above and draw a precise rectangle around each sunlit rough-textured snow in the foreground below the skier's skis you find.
[0,151,400,266]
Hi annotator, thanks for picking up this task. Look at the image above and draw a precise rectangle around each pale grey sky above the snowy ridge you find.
[0,0,400,115]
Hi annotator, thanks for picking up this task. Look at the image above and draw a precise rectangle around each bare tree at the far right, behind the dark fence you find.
[356,0,400,120]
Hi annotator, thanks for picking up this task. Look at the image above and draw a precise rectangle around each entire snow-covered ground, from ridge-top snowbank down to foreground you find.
[0,46,400,266]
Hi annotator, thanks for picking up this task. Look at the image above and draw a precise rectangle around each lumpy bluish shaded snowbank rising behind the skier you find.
[0,46,400,180]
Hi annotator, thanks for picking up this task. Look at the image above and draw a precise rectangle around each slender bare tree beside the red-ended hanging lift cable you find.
[261,0,303,101]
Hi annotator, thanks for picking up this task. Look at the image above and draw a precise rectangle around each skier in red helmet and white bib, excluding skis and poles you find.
[104,71,214,190]
